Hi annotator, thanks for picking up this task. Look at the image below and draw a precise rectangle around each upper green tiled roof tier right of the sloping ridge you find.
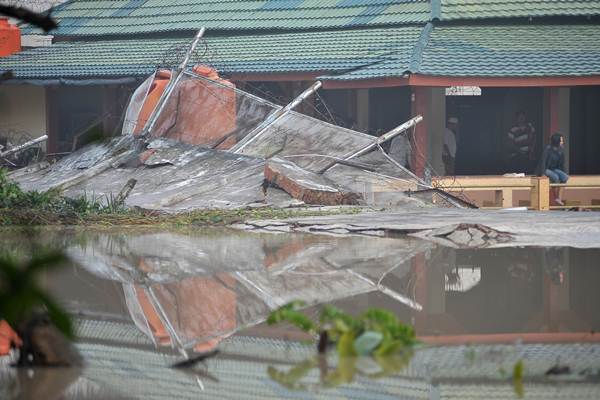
[432,0,600,21]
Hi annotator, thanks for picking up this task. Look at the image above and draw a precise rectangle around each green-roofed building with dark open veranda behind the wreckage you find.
[0,0,600,175]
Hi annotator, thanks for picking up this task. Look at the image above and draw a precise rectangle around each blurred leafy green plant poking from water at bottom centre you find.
[267,301,417,390]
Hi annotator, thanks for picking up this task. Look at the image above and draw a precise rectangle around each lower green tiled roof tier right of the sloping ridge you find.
[412,24,600,77]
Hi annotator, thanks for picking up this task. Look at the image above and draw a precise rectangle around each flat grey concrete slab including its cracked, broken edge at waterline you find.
[234,208,600,248]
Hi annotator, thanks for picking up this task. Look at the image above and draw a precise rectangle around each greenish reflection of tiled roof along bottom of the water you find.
[63,321,600,399]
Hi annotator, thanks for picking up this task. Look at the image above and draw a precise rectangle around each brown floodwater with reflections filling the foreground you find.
[0,228,600,399]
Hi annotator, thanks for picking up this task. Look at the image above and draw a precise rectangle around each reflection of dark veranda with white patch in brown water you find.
[413,248,600,340]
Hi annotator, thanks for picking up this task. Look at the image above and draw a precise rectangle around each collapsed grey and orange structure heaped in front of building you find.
[13,30,458,211]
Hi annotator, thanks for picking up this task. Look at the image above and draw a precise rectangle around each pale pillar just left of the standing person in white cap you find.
[428,88,446,175]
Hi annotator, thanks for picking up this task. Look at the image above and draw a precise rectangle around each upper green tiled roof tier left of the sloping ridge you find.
[23,0,430,36]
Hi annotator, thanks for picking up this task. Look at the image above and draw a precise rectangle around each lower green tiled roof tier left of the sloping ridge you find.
[0,26,422,79]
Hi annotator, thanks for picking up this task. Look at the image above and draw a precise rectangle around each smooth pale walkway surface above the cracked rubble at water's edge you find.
[238,209,600,248]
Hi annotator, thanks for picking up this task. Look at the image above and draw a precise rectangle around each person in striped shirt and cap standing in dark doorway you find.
[507,111,535,173]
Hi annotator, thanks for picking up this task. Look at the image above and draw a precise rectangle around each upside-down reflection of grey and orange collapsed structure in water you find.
[69,230,430,352]
